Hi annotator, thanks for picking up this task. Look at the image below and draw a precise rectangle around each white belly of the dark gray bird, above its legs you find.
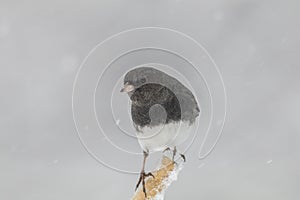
[137,122,195,152]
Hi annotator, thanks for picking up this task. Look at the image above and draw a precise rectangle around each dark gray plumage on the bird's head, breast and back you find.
[124,67,200,130]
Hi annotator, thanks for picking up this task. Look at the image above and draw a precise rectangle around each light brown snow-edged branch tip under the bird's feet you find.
[132,156,182,200]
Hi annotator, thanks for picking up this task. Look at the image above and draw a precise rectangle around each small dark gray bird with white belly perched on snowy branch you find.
[120,66,200,196]
